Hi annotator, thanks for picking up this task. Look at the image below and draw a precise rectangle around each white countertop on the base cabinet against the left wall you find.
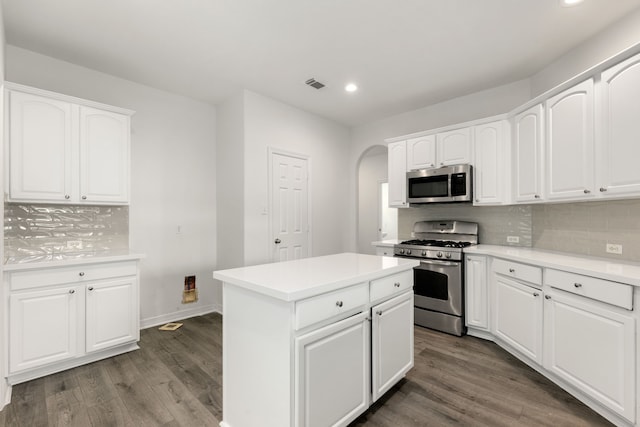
[2,251,145,271]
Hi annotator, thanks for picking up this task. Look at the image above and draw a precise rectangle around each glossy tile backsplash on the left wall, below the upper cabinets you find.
[4,203,129,263]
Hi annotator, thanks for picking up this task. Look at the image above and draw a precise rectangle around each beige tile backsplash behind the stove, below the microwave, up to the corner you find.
[398,203,531,246]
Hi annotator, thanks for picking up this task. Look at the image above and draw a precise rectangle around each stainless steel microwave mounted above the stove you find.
[407,164,473,204]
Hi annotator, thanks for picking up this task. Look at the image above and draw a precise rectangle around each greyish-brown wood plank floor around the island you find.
[0,314,611,427]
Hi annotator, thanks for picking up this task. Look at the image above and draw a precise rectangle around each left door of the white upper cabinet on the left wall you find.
[9,92,77,202]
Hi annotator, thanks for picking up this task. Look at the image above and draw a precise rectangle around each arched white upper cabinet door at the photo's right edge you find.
[598,51,640,196]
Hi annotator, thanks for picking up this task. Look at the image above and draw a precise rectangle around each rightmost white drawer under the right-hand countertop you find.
[545,269,633,310]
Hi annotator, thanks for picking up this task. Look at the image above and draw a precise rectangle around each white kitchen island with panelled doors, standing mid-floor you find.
[213,253,418,427]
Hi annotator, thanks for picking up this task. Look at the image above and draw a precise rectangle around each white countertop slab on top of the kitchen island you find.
[213,253,420,301]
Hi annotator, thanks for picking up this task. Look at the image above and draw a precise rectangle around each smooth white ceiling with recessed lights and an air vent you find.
[3,0,640,125]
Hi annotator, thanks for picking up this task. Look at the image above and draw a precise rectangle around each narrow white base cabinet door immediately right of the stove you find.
[465,255,489,335]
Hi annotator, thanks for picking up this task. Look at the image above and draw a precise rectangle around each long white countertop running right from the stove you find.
[464,245,640,286]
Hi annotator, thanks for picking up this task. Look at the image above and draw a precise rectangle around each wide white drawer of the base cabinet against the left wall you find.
[9,261,137,291]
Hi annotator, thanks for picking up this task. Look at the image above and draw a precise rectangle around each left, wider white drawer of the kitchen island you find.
[295,282,369,330]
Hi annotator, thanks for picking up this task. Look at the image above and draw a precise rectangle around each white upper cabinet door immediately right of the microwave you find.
[473,120,509,205]
